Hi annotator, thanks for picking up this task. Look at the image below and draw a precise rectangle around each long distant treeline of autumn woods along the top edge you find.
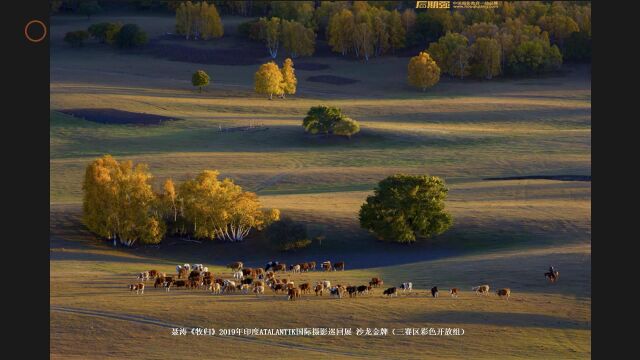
[51,0,591,73]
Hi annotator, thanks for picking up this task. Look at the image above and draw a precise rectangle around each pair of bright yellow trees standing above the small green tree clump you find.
[254,58,298,100]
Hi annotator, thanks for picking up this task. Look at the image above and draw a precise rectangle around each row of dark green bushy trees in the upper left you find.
[64,22,148,49]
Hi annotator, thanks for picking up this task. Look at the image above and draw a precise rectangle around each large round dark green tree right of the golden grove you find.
[359,174,453,243]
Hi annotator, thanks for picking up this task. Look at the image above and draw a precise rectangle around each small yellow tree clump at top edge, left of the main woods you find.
[176,1,224,40]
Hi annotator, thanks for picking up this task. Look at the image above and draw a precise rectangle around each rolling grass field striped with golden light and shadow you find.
[50,16,591,359]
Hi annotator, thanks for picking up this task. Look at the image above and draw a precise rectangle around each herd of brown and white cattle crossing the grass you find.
[129,261,511,300]
